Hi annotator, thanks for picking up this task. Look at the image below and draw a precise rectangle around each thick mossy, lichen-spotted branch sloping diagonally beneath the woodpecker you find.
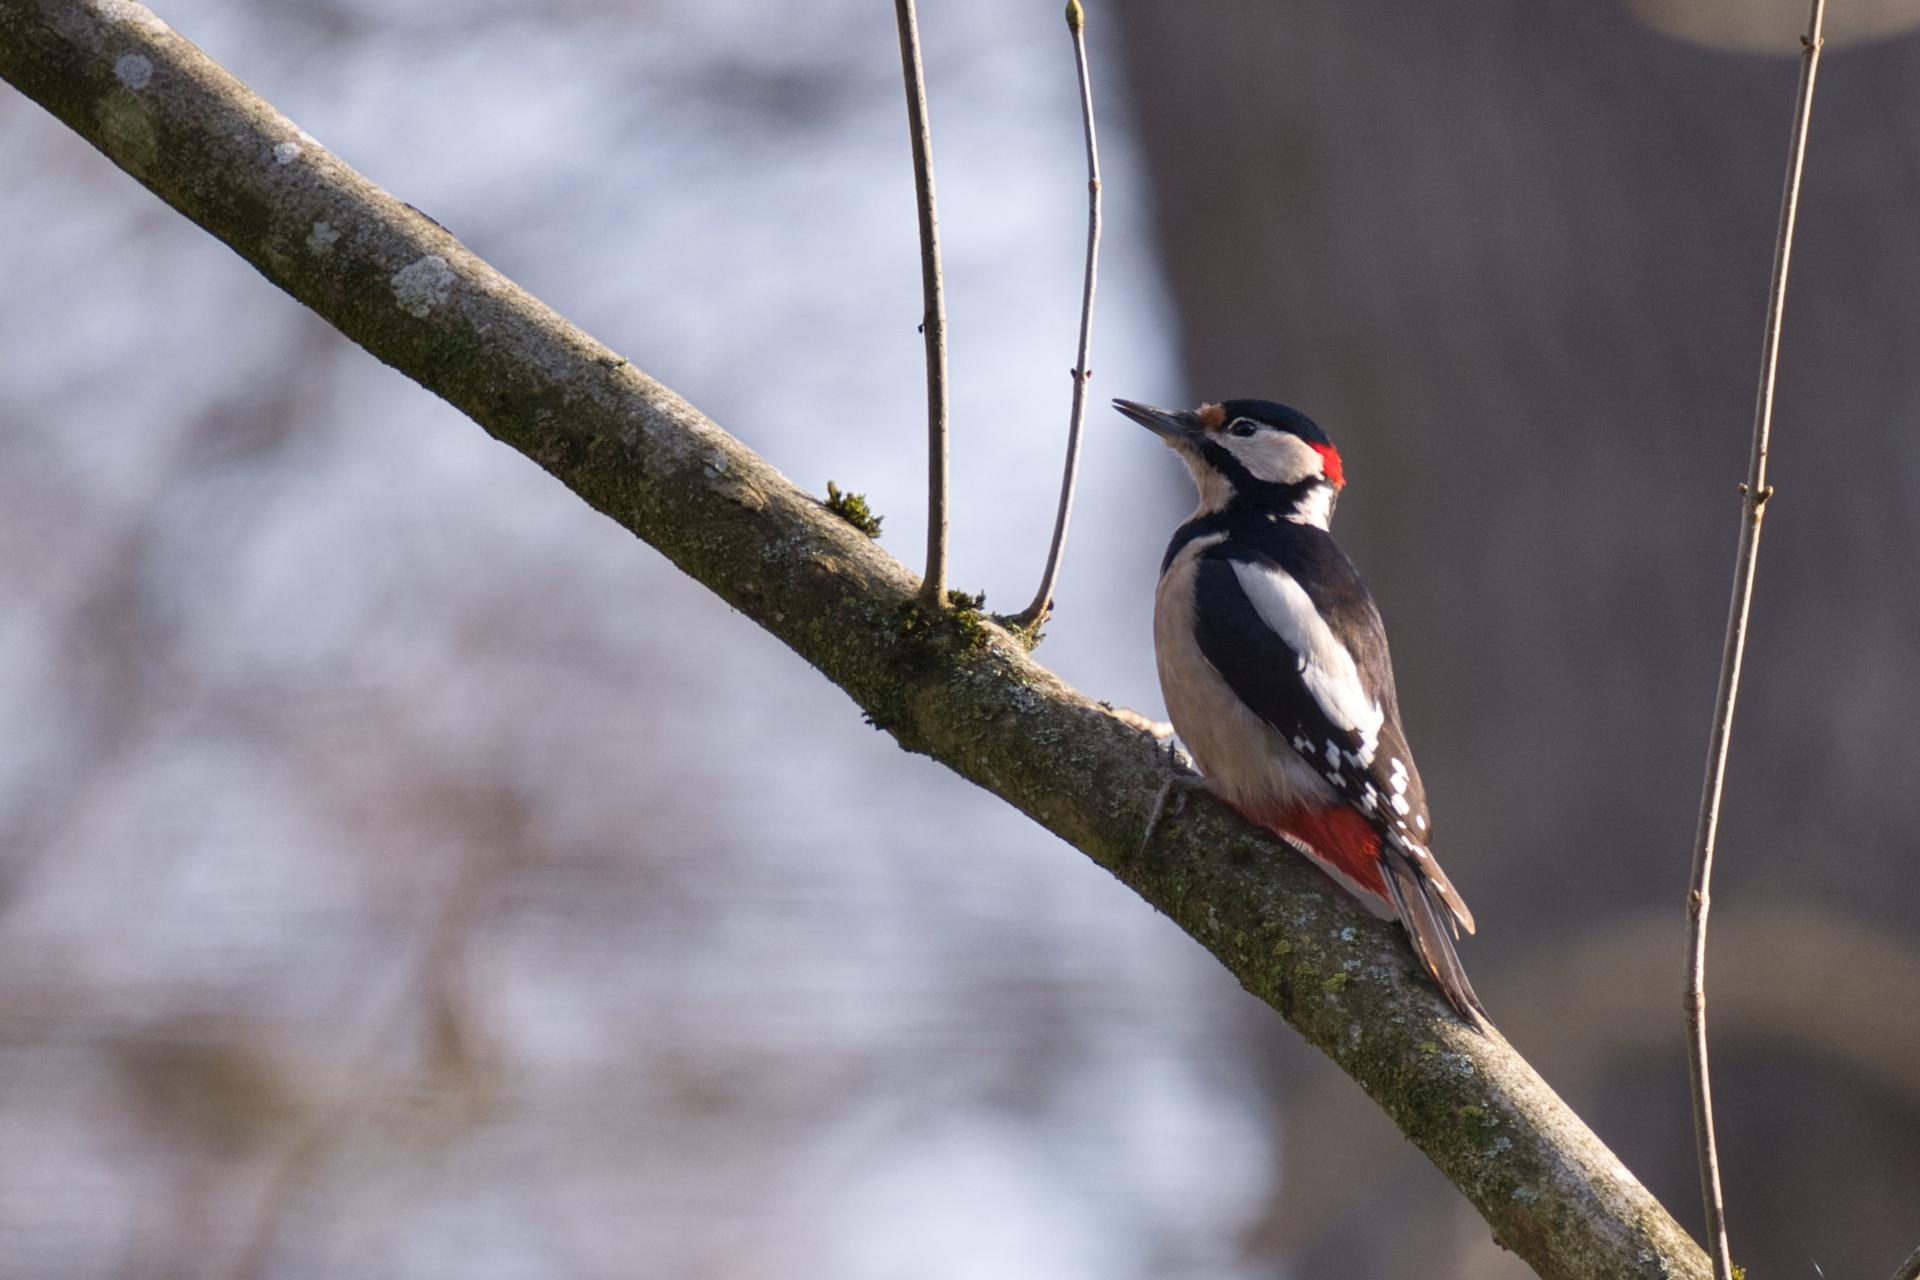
[0,0,1707,1280]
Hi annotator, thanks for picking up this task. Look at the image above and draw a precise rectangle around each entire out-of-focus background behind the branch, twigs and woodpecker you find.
[0,0,1920,1280]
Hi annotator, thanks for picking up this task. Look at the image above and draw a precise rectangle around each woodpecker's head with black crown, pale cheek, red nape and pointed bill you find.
[1114,399,1346,528]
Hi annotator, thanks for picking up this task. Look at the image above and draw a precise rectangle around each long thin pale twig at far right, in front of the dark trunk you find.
[1686,0,1826,1280]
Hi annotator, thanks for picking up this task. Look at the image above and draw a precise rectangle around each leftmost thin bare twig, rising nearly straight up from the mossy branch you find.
[893,0,947,608]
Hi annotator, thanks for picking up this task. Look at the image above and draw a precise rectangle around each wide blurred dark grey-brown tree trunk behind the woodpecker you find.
[1116,0,1920,1276]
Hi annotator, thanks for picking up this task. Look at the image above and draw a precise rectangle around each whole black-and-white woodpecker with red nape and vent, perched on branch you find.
[1114,399,1486,1027]
